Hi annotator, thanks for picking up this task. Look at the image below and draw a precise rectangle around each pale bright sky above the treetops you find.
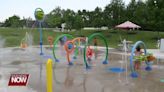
[0,0,130,22]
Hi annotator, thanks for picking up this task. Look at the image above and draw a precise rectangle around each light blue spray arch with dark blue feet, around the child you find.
[130,41,152,78]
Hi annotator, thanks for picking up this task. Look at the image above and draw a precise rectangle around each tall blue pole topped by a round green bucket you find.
[34,8,44,55]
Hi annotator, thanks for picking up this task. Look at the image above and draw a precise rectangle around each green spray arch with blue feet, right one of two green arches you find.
[84,33,108,69]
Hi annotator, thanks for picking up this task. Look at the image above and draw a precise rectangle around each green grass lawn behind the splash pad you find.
[0,28,164,48]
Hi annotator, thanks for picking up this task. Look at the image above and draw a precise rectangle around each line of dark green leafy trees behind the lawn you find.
[2,0,164,31]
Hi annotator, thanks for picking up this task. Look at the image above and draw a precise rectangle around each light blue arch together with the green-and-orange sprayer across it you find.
[130,41,155,78]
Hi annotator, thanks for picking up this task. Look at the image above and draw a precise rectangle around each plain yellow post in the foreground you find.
[46,59,52,92]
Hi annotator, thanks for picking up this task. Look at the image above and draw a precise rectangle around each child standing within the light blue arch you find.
[134,46,143,69]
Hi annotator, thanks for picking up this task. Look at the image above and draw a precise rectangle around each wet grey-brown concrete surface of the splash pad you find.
[0,48,164,92]
